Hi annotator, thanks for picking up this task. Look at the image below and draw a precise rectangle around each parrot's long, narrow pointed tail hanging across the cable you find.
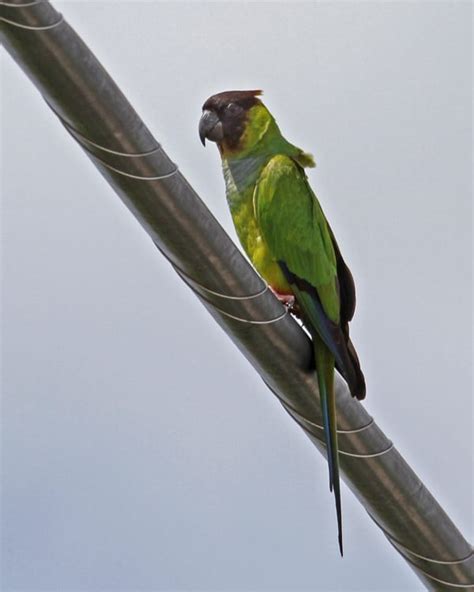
[313,335,344,557]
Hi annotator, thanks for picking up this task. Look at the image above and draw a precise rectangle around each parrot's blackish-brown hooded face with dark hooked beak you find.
[199,90,262,148]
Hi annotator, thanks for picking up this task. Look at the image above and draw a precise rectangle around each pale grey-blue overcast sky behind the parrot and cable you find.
[1,1,473,592]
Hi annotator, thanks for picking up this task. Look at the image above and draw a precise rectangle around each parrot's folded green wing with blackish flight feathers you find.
[254,155,365,399]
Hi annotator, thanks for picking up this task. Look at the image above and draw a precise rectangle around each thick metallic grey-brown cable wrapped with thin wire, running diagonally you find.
[0,0,474,591]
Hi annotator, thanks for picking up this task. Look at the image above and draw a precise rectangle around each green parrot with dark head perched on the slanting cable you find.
[199,90,365,555]
